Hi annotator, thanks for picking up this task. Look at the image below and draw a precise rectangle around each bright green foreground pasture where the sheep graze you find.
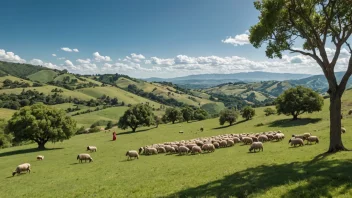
[0,91,352,198]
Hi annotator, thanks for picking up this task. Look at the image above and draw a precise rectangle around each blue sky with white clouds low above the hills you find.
[0,0,348,78]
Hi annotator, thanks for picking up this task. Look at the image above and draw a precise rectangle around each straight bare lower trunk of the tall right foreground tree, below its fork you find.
[328,92,347,153]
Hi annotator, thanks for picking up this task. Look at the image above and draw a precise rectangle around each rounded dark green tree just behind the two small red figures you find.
[117,104,154,132]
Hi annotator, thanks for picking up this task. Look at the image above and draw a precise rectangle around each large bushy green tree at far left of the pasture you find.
[8,103,76,149]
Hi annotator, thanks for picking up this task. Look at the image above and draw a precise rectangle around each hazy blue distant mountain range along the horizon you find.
[143,72,311,89]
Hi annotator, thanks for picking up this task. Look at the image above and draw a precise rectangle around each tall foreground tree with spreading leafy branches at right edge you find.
[249,0,352,152]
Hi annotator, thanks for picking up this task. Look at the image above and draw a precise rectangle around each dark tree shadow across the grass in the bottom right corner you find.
[167,160,352,198]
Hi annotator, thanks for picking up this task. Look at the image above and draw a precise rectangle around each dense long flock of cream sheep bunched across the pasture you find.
[126,131,319,160]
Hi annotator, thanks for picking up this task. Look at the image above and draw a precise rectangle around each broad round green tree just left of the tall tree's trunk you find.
[276,86,324,120]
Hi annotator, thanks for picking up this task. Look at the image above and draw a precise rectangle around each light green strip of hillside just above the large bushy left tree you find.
[0,85,94,100]
